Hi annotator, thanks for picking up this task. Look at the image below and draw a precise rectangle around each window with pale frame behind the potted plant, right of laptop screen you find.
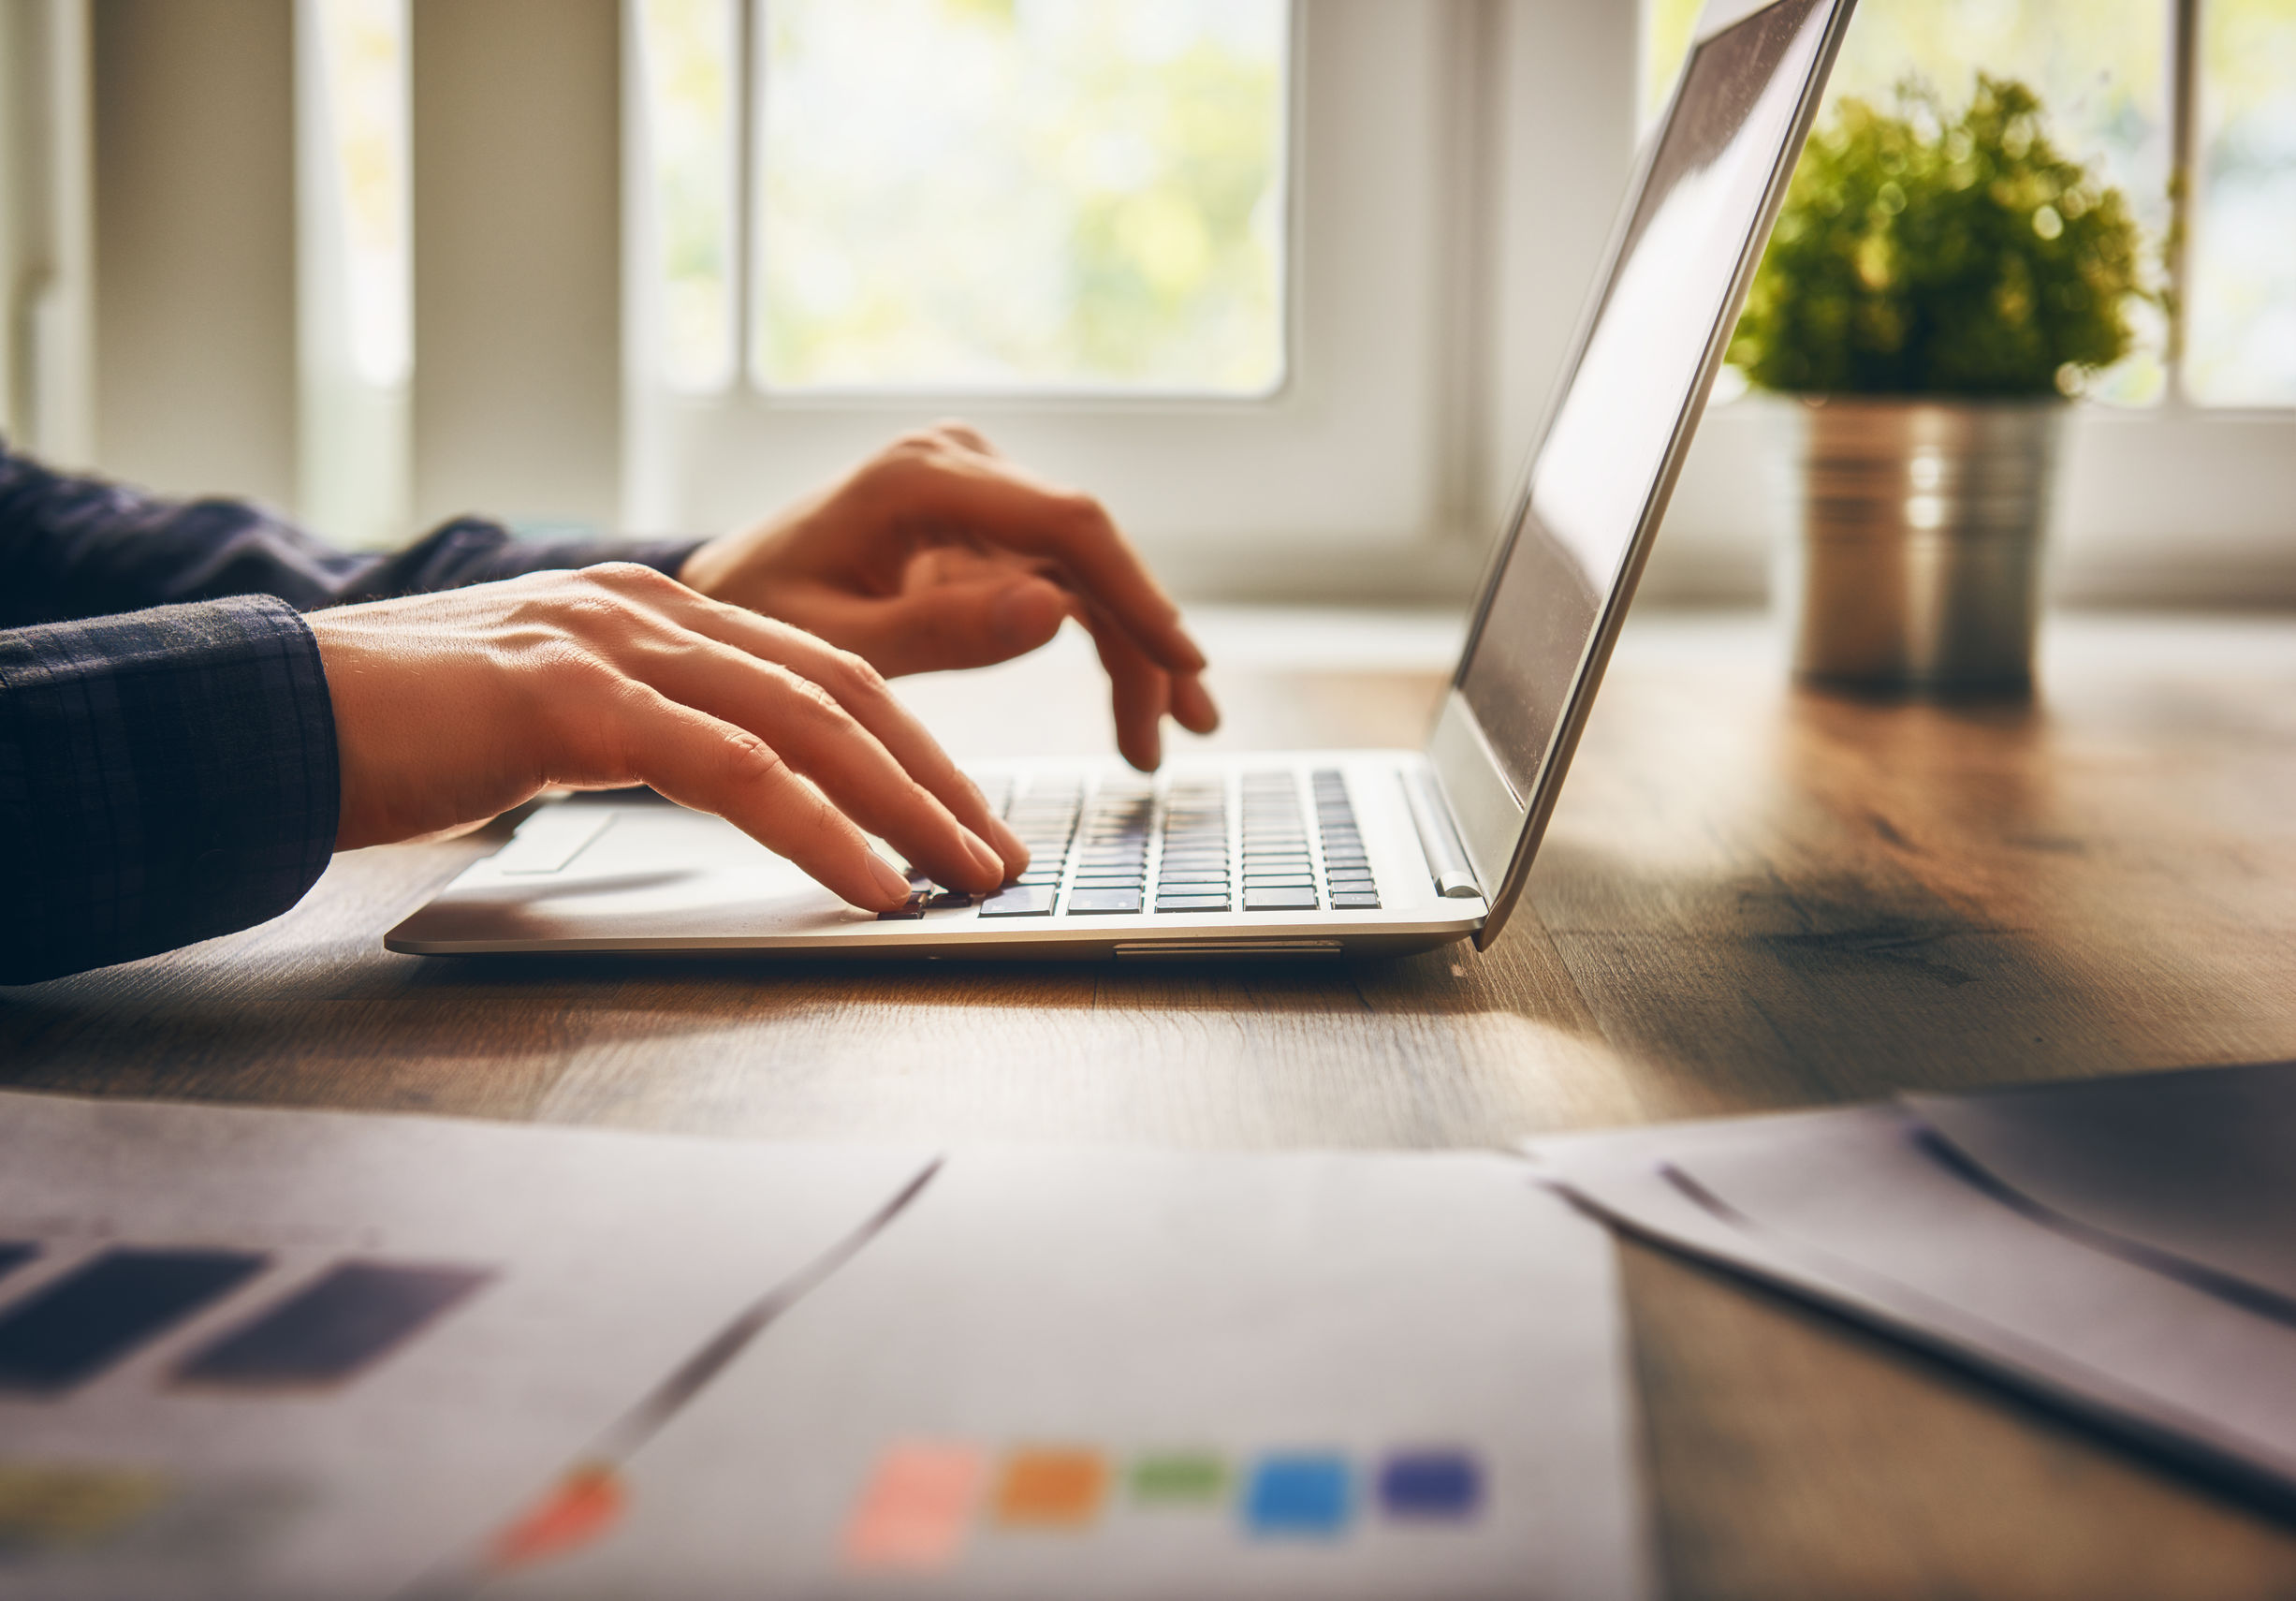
[1637,0,2296,607]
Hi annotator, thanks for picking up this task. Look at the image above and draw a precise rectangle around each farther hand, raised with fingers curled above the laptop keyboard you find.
[678,422,1220,771]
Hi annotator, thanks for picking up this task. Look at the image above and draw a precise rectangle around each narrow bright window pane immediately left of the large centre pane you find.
[638,0,737,390]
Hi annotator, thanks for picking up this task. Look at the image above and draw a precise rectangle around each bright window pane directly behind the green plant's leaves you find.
[1644,0,2157,404]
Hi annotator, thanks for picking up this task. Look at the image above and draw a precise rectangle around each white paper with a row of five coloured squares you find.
[482,1151,1646,1601]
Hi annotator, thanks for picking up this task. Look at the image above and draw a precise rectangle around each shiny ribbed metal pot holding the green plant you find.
[1777,400,2064,694]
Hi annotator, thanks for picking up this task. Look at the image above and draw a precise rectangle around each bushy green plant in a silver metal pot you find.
[1729,76,2156,691]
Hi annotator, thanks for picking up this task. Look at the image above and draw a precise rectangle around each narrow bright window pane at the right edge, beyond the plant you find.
[2186,0,2296,406]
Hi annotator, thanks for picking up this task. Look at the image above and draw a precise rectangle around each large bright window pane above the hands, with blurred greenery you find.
[753,0,1291,395]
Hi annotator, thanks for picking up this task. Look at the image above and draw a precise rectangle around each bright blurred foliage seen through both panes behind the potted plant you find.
[1642,0,2296,406]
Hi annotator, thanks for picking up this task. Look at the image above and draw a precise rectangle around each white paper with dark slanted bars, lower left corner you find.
[0,1095,928,1601]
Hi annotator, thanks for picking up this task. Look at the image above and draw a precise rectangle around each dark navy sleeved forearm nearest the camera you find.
[0,597,340,983]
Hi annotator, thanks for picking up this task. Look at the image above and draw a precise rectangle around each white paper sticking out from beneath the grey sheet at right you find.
[1527,1108,2296,1495]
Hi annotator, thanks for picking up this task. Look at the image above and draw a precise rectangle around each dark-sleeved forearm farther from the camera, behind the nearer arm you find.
[0,450,694,627]
